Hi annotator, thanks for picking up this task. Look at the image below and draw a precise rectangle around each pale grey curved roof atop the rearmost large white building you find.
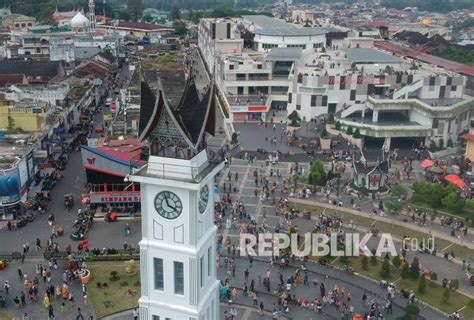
[243,15,335,36]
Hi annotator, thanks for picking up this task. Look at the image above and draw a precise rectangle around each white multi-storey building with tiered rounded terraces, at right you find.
[288,44,474,149]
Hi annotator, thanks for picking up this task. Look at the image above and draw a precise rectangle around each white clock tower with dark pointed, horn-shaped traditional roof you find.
[129,70,223,320]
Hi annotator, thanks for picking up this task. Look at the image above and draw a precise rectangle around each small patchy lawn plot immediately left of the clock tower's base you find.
[87,261,140,318]
